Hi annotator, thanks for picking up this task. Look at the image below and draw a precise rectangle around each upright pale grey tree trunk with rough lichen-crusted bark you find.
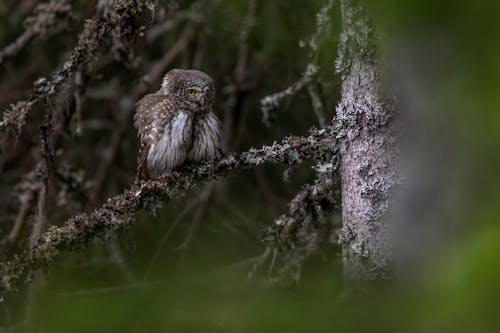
[335,0,398,281]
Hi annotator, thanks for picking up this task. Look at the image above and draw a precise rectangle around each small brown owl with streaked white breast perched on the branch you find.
[134,69,222,179]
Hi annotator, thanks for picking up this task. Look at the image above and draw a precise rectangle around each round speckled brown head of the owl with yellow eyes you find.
[161,69,215,111]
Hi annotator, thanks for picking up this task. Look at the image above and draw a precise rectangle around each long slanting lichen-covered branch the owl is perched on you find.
[0,128,336,297]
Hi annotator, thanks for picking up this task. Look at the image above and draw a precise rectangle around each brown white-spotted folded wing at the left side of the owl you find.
[134,94,170,179]
